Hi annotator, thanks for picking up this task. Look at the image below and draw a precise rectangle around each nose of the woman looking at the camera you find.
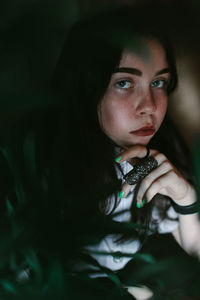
[136,89,157,115]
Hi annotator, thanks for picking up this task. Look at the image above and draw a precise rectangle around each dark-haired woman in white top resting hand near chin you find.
[50,7,200,276]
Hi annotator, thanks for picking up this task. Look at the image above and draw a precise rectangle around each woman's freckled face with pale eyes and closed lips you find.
[98,40,170,148]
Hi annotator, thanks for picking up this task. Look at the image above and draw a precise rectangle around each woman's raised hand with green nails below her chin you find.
[116,145,196,207]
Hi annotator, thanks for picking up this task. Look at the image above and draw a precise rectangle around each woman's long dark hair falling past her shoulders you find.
[51,6,191,239]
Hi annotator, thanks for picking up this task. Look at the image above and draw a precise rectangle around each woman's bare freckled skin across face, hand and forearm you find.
[97,40,200,258]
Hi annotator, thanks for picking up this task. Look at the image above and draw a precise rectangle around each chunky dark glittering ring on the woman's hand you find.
[123,156,158,185]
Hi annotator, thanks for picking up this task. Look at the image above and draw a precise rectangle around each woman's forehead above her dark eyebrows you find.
[119,40,168,69]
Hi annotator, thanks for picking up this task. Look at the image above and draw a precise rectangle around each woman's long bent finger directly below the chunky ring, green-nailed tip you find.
[137,160,173,204]
